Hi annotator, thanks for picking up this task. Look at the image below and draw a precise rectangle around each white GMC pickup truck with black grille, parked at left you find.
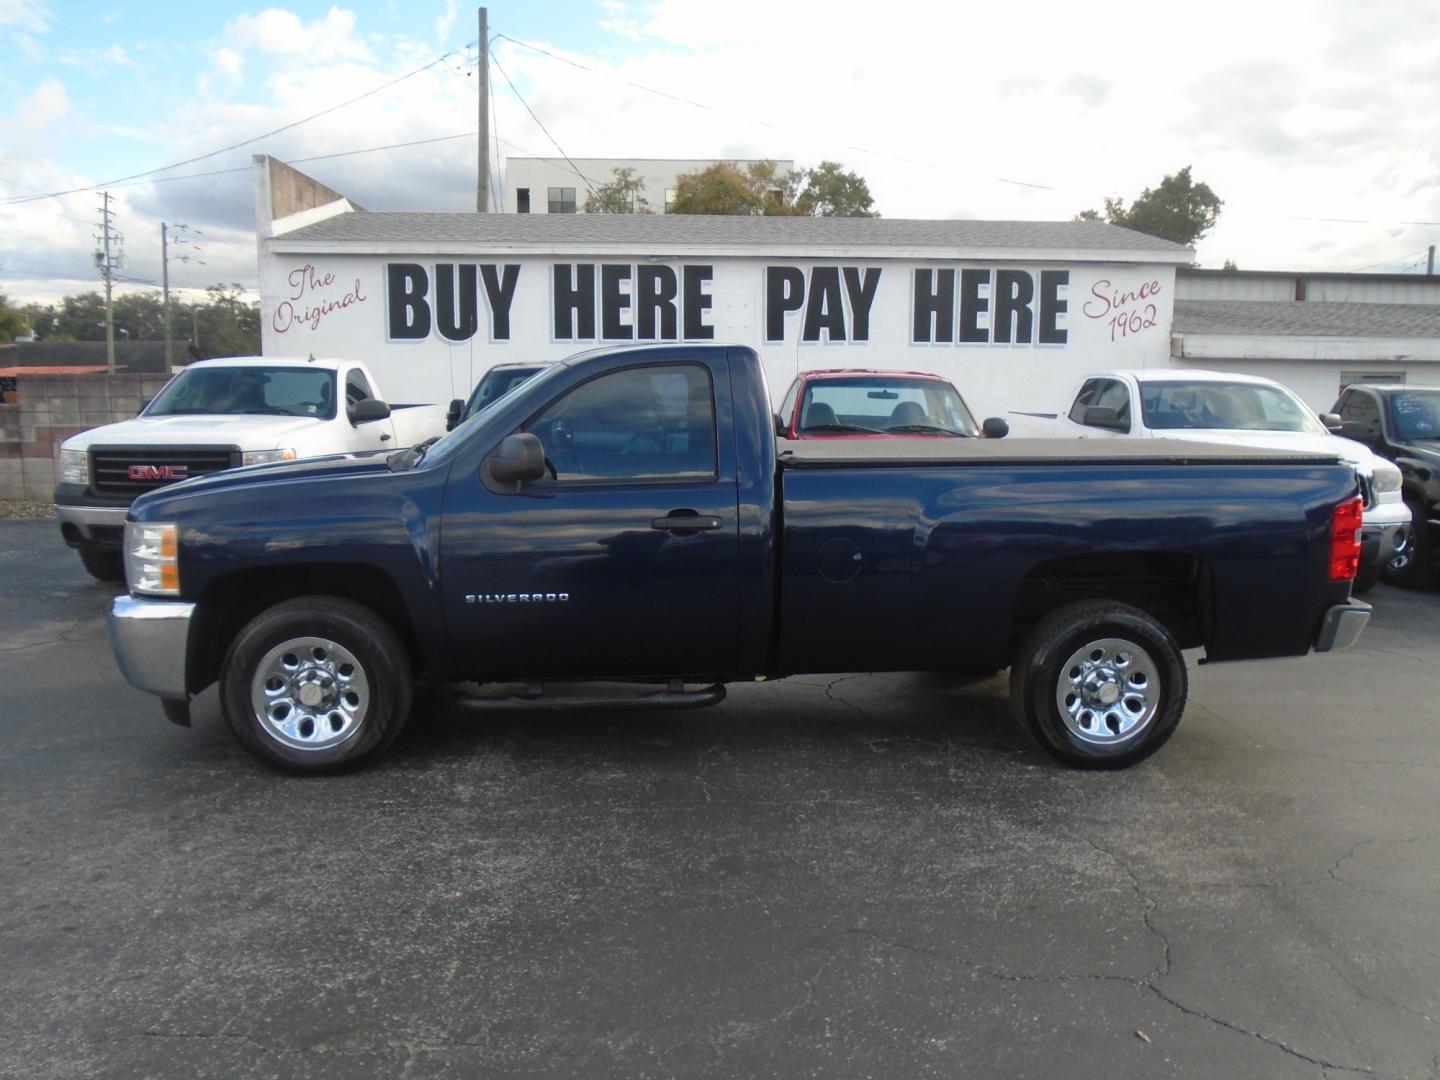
[55,357,445,582]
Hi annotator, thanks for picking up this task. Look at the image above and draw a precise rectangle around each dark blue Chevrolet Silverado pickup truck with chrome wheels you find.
[109,344,1369,772]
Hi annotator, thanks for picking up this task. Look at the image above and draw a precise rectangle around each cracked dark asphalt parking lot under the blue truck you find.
[0,520,1440,1077]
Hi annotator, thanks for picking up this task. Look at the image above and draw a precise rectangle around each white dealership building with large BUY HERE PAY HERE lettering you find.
[256,158,1192,416]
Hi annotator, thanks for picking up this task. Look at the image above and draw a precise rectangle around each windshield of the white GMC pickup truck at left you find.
[144,367,336,420]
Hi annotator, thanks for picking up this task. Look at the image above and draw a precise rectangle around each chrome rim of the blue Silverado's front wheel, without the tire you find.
[251,638,370,750]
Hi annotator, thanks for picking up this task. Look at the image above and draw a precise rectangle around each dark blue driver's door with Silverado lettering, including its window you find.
[442,350,739,678]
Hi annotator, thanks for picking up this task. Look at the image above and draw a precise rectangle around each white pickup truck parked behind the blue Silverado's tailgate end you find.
[1028,369,1411,593]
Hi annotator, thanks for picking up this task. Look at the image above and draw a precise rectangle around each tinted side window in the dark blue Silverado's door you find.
[521,364,716,482]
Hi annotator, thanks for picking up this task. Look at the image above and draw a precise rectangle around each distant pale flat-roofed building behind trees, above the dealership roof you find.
[500,157,795,213]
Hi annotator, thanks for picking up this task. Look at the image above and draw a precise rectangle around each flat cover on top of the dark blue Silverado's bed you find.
[775,438,1344,469]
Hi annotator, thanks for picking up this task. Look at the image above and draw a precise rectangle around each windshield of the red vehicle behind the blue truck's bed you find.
[799,374,978,435]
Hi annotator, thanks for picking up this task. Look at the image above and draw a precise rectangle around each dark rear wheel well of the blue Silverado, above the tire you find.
[1008,552,1214,655]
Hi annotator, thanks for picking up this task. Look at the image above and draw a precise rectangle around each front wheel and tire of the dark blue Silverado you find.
[220,596,413,773]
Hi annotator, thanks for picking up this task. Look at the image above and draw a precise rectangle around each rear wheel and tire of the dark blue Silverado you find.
[1009,600,1189,769]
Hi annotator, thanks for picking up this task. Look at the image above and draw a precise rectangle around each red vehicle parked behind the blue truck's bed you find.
[775,369,1009,439]
